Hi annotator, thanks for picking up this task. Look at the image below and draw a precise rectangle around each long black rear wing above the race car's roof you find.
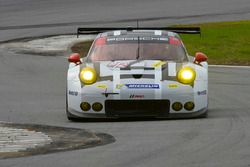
[77,27,201,38]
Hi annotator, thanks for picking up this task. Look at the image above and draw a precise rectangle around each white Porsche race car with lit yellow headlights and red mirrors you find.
[66,28,208,120]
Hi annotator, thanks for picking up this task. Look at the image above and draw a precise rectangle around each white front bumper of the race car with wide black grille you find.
[67,80,207,118]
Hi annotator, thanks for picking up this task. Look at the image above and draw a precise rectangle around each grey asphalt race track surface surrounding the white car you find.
[0,0,250,167]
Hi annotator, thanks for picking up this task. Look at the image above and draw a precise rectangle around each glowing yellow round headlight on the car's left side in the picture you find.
[80,67,96,84]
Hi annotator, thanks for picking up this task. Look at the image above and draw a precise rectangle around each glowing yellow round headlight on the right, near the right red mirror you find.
[177,67,196,84]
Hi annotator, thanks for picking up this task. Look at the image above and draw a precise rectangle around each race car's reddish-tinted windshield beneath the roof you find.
[88,37,187,62]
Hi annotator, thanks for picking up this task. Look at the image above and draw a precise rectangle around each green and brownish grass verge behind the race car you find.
[71,20,250,65]
